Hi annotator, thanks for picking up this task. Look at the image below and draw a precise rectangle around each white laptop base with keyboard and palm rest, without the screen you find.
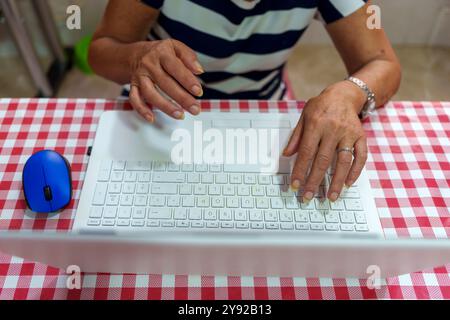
[74,111,383,237]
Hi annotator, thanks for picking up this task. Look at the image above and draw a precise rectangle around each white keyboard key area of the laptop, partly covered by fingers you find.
[86,160,370,233]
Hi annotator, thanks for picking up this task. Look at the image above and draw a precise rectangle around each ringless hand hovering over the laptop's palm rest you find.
[130,39,204,122]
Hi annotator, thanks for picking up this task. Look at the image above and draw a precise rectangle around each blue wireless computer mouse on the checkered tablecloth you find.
[22,150,72,213]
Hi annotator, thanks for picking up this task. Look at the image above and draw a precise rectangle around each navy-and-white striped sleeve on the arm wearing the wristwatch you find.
[318,0,368,24]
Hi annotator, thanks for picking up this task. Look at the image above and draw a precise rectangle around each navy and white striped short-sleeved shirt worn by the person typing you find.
[133,0,367,100]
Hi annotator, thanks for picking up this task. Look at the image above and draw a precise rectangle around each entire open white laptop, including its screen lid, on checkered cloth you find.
[0,111,450,278]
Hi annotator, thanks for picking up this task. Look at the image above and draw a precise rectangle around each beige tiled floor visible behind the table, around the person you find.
[0,46,450,101]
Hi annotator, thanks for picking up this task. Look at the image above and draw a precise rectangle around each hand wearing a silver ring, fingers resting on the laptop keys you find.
[283,81,367,203]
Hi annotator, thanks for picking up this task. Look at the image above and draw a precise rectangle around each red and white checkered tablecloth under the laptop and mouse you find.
[0,99,450,299]
